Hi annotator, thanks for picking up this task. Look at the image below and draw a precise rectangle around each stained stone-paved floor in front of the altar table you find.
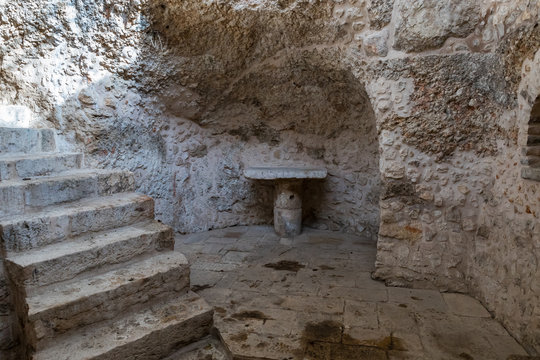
[176,226,527,360]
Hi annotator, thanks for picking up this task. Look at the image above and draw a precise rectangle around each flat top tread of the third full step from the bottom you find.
[6,220,169,267]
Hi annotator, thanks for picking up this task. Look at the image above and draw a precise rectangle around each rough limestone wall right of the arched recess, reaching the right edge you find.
[367,1,540,354]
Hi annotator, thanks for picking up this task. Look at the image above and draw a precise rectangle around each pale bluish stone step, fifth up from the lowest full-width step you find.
[0,169,135,218]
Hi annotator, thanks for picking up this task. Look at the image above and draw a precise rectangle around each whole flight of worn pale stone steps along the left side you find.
[0,128,213,360]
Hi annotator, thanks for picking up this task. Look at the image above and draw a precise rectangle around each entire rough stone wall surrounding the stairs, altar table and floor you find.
[0,0,540,352]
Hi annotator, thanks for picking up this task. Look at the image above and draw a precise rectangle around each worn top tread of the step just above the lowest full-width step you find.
[27,251,188,317]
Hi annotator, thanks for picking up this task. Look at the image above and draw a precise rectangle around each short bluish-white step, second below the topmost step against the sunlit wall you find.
[0,153,82,181]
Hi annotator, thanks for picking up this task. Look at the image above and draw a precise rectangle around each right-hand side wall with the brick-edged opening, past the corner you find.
[469,44,540,355]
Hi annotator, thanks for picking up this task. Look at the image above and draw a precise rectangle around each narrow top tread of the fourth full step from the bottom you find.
[0,192,151,227]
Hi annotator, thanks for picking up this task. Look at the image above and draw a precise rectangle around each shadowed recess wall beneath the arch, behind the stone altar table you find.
[171,51,380,236]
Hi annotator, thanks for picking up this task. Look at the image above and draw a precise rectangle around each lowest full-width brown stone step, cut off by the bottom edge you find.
[32,292,213,360]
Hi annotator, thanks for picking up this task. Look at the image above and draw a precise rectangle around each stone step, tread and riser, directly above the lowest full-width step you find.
[23,251,189,349]
